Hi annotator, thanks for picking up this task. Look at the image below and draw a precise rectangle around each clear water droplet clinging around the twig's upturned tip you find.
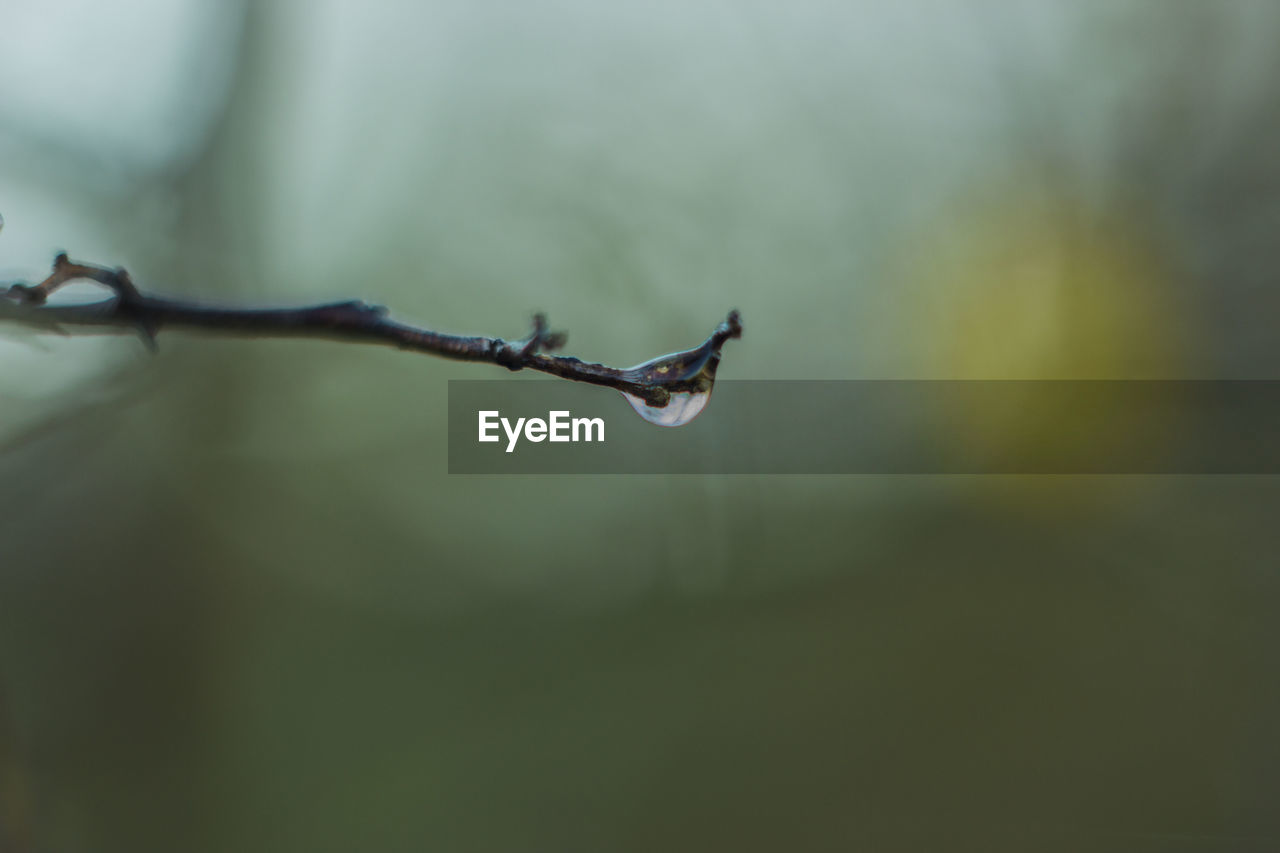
[622,311,742,427]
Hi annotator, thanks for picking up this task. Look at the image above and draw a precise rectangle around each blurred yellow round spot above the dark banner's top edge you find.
[905,197,1187,379]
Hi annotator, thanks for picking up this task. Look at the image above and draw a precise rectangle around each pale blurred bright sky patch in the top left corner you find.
[0,0,237,174]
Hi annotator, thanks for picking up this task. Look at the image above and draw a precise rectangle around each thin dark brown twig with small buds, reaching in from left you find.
[0,255,742,406]
